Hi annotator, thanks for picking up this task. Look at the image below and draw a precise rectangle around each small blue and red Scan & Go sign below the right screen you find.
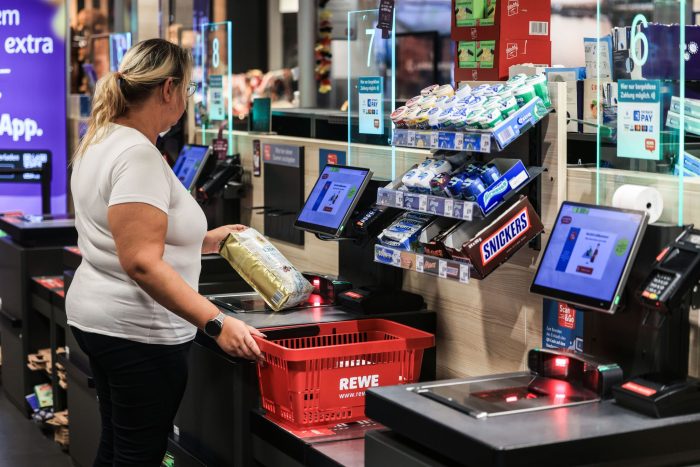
[542,298,583,352]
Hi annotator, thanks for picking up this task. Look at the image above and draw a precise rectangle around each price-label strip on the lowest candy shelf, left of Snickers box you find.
[374,245,472,284]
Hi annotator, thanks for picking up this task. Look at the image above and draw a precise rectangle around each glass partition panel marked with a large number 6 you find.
[596,0,688,225]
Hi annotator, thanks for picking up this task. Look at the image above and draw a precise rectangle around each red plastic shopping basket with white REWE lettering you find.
[253,319,435,428]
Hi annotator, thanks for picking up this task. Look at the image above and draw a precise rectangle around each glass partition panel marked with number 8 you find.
[197,21,233,155]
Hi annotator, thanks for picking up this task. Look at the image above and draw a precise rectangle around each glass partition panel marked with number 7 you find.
[347,9,396,180]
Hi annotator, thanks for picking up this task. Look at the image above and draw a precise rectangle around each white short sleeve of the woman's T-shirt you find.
[107,144,172,214]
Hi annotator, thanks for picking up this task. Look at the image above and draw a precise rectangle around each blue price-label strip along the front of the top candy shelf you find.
[392,97,551,153]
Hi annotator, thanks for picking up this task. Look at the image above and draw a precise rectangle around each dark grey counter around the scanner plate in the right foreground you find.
[366,378,700,465]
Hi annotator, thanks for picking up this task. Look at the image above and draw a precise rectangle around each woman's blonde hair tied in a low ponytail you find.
[71,39,192,162]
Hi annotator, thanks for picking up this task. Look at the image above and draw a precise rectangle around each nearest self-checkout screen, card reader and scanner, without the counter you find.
[418,202,700,417]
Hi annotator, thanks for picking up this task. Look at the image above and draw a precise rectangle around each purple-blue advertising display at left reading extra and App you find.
[0,0,66,213]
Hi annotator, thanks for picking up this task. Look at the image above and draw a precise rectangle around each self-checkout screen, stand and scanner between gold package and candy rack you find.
[210,165,424,314]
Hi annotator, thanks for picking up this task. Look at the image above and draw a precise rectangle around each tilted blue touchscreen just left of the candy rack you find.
[297,165,370,233]
